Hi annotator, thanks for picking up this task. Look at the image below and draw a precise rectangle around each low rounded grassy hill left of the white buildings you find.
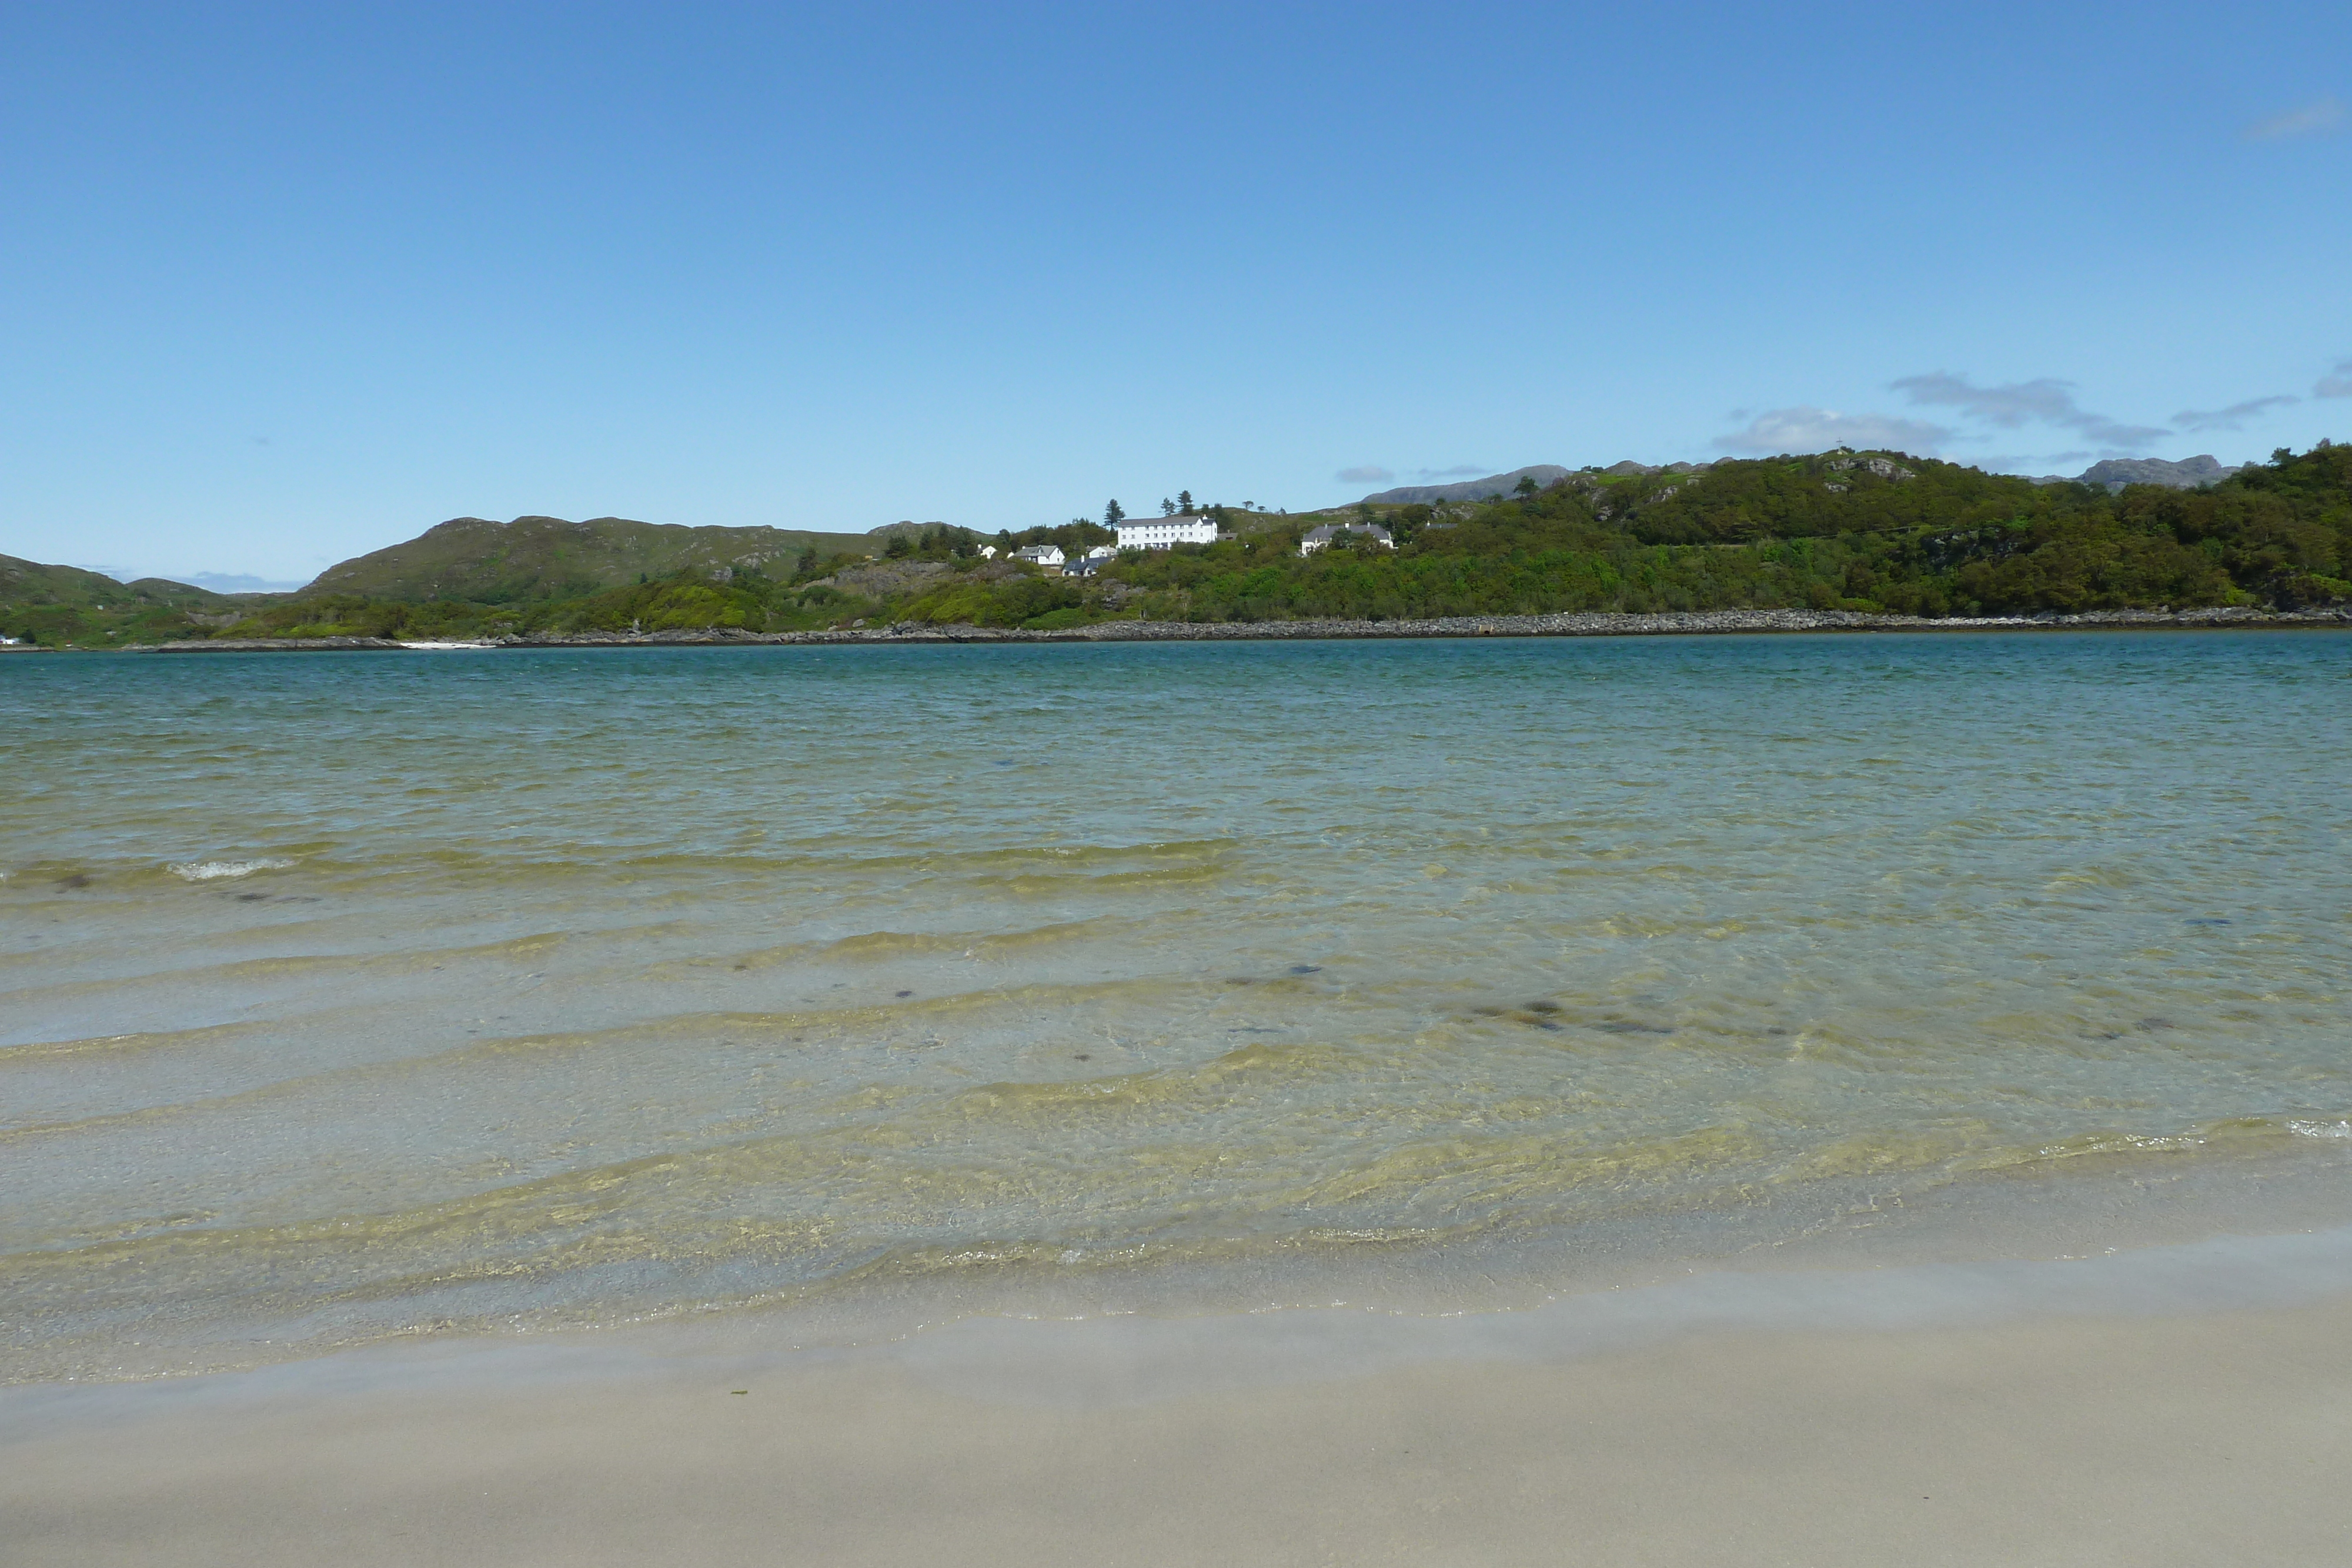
[299,517,887,604]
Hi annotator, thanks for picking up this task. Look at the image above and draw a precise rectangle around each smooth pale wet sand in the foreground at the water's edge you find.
[0,1269,2352,1566]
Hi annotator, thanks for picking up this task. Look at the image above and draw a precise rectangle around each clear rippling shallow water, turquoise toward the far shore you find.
[0,633,2352,1378]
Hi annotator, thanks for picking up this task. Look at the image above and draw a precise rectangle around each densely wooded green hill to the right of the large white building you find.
[1143,442,2352,621]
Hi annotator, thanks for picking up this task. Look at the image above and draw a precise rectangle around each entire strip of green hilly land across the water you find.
[14,442,2352,647]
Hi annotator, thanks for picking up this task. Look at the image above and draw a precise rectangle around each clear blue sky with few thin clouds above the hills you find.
[0,0,2352,579]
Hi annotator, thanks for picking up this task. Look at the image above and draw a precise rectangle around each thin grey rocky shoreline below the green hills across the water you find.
[125,607,2352,654]
